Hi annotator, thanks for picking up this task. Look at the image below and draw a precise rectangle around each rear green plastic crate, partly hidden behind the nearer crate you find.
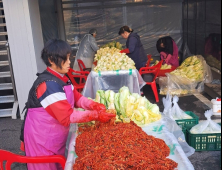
[176,111,199,129]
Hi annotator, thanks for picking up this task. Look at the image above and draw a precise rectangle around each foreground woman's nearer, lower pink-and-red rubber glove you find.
[70,110,116,123]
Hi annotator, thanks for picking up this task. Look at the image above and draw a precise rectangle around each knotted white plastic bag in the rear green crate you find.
[171,96,192,120]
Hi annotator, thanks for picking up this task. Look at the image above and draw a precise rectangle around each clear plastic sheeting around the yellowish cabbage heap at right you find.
[159,56,213,96]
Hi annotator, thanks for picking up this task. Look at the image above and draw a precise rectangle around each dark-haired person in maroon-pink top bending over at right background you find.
[156,36,179,67]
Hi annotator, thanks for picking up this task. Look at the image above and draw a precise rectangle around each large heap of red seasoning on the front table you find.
[73,122,178,170]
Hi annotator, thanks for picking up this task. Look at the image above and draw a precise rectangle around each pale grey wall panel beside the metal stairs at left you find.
[3,0,45,117]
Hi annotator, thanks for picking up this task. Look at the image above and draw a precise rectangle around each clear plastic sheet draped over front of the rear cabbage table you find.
[82,70,146,99]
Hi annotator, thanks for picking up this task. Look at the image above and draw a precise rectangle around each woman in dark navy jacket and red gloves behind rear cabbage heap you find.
[119,26,148,70]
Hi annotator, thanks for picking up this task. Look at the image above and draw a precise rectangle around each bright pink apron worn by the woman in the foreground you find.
[24,85,74,170]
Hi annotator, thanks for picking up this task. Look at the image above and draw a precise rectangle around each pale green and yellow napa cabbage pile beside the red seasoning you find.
[95,87,161,126]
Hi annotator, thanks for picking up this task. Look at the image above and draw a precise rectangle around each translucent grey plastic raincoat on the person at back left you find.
[73,34,99,71]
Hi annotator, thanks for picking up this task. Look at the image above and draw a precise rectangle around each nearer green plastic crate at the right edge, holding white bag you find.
[186,124,221,152]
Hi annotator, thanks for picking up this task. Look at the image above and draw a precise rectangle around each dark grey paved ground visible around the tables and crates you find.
[0,84,221,170]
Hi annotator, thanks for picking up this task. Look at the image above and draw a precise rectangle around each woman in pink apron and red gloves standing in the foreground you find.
[21,40,115,170]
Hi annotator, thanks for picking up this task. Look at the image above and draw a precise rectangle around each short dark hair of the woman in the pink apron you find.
[41,39,72,68]
